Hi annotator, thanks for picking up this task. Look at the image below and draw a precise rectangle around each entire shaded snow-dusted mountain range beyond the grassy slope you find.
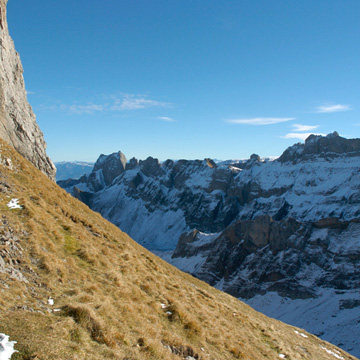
[60,133,360,356]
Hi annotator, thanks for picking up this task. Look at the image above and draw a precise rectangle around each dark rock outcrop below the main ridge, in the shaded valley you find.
[172,215,360,299]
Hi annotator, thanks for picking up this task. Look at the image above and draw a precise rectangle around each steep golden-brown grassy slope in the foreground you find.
[0,141,355,360]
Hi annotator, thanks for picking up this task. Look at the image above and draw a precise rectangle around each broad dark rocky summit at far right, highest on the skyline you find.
[278,131,360,163]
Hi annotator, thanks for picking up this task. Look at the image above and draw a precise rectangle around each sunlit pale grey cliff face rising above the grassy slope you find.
[0,0,56,180]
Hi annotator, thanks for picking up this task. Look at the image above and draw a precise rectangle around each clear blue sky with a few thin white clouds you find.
[8,0,360,161]
